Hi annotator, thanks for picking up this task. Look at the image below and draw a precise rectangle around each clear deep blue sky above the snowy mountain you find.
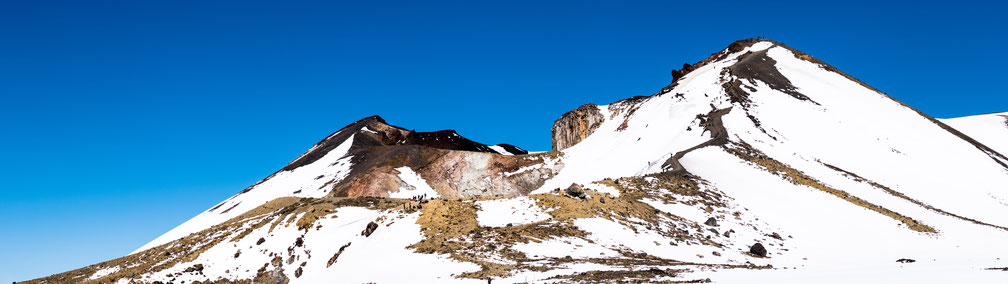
[0,0,1008,283]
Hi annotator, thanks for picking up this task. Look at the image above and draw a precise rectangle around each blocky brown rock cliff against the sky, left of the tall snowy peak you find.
[553,104,606,151]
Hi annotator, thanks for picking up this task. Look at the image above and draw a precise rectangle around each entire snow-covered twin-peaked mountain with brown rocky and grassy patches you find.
[25,39,1008,283]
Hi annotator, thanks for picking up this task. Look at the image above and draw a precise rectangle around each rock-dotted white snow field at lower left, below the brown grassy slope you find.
[143,207,477,283]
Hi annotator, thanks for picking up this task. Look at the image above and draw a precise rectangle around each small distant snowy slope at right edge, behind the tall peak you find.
[941,113,1008,155]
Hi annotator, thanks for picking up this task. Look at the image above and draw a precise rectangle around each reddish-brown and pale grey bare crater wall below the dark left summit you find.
[327,140,558,197]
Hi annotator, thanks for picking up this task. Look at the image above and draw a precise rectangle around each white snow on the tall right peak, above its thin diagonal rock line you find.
[537,41,1008,226]
